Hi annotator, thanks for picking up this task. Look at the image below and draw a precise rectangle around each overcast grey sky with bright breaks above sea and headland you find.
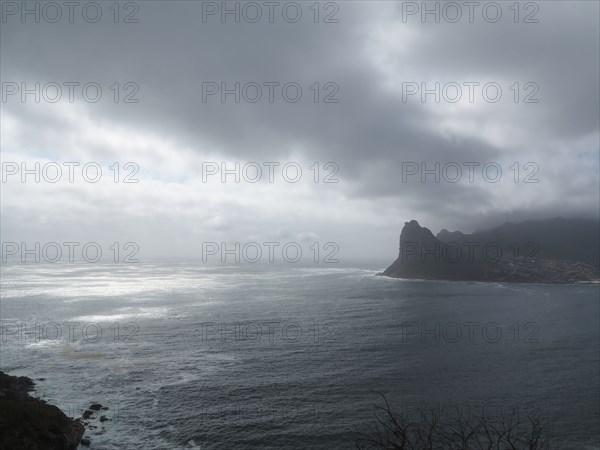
[0,1,600,264]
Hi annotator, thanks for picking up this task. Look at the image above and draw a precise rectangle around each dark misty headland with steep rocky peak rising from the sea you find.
[382,217,600,283]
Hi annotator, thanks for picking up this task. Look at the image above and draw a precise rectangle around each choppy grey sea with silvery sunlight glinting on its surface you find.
[0,264,600,449]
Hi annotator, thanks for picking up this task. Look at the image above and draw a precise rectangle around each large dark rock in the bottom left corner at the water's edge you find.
[0,371,84,450]
